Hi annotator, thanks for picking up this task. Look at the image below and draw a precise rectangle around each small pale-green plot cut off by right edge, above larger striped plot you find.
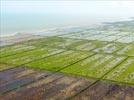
[117,44,134,56]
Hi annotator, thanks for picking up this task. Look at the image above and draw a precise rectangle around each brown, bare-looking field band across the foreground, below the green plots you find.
[0,67,134,100]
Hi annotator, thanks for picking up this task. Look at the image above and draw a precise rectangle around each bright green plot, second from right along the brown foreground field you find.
[61,54,125,78]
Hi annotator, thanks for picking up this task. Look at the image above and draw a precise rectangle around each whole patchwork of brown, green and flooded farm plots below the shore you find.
[0,21,134,100]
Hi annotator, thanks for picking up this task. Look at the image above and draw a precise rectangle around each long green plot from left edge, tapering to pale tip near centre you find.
[0,48,63,65]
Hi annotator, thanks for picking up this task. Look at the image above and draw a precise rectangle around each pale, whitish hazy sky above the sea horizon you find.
[1,0,134,14]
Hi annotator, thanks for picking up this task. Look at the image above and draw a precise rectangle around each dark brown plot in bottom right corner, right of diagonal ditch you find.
[73,81,134,100]
